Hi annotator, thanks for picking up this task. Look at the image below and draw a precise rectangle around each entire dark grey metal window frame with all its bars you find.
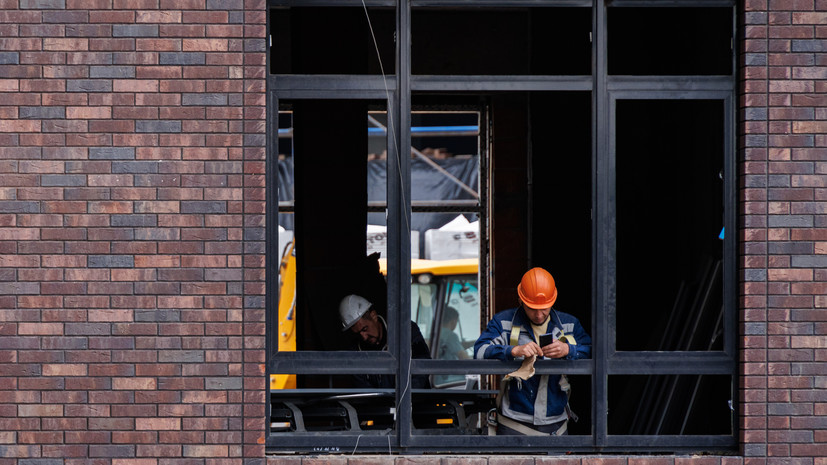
[266,0,738,453]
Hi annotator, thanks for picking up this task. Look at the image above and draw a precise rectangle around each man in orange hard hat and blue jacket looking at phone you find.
[474,268,592,435]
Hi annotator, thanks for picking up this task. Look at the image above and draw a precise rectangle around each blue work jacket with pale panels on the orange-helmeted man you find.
[474,307,592,425]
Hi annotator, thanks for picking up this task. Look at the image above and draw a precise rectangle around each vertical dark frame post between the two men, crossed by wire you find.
[388,0,413,447]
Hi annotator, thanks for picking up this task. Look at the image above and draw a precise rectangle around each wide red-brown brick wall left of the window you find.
[0,0,266,465]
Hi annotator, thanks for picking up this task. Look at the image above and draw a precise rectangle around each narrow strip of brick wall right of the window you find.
[740,0,827,465]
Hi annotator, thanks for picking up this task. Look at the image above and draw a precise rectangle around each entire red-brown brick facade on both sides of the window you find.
[0,0,827,465]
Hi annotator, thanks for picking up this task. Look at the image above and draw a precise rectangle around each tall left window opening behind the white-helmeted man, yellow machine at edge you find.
[278,101,385,350]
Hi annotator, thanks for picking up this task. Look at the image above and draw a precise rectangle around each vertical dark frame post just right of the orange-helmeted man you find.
[592,0,614,447]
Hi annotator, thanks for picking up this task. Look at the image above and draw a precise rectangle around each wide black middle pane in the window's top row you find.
[411,8,592,75]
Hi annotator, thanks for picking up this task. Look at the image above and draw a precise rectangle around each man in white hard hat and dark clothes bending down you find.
[339,294,431,389]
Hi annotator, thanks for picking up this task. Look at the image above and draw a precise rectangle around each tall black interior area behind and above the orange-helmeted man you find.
[529,92,592,333]
